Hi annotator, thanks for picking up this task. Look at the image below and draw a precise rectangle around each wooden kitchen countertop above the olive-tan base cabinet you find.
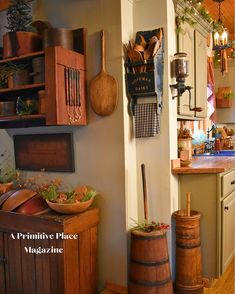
[172,156,235,174]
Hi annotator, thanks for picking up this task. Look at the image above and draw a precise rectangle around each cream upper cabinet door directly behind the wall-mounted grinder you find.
[178,23,194,117]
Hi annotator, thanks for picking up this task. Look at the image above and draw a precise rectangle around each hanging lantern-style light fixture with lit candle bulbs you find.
[213,0,230,50]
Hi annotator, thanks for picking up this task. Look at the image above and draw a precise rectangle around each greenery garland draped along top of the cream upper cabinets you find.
[176,0,223,33]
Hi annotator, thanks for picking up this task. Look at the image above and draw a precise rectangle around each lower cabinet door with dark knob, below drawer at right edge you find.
[222,191,235,274]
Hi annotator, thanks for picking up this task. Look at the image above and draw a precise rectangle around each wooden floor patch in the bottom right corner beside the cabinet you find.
[204,258,235,294]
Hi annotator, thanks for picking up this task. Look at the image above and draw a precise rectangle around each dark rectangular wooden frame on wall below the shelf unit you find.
[13,133,75,172]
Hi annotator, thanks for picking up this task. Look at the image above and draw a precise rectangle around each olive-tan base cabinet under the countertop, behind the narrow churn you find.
[179,170,235,278]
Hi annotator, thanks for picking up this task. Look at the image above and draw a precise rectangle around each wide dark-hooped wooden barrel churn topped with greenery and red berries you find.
[128,231,173,294]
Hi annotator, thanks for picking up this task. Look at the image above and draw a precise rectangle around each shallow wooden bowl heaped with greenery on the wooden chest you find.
[46,197,94,214]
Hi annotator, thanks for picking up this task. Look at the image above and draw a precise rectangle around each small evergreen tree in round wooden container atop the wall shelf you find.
[3,0,42,58]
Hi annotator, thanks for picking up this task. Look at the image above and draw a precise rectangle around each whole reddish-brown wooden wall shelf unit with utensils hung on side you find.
[0,29,87,128]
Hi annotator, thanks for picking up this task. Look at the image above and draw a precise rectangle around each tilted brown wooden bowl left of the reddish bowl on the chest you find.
[2,189,37,211]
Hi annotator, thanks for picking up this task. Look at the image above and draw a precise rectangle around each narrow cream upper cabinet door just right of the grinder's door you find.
[195,31,207,118]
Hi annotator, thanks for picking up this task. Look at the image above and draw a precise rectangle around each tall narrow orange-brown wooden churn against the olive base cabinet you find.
[174,210,203,294]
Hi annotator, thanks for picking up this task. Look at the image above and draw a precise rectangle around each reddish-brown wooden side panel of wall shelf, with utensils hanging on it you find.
[45,46,87,125]
